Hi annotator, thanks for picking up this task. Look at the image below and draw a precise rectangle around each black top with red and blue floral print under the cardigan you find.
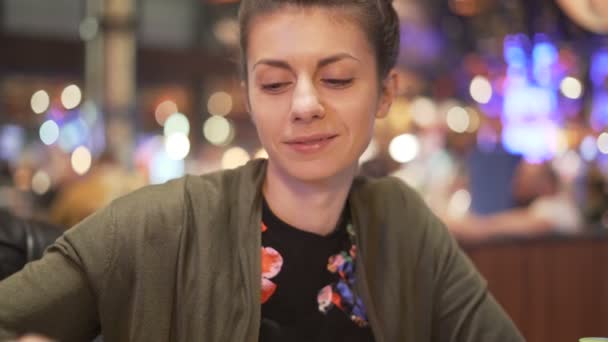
[260,202,374,342]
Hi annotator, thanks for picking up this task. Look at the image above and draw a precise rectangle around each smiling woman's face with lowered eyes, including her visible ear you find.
[247,7,394,181]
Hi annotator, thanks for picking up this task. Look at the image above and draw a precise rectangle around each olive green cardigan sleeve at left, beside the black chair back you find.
[0,204,114,341]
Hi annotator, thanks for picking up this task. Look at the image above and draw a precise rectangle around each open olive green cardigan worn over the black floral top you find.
[0,160,523,342]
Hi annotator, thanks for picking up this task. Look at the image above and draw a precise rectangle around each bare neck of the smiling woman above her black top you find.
[262,162,356,236]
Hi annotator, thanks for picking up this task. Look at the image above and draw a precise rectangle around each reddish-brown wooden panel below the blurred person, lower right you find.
[464,234,608,342]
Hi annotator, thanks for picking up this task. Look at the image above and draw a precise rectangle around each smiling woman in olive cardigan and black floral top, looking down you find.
[0,0,522,342]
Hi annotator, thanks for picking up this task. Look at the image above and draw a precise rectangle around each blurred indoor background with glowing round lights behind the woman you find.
[0,0,608,341]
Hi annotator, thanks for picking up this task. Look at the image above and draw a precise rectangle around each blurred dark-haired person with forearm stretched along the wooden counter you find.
[445,160,583,242]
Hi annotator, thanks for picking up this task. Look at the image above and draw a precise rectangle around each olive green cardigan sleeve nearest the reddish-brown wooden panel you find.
[426,213,524,342]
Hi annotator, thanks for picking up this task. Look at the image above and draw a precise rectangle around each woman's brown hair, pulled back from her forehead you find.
[239,0,399,80]
